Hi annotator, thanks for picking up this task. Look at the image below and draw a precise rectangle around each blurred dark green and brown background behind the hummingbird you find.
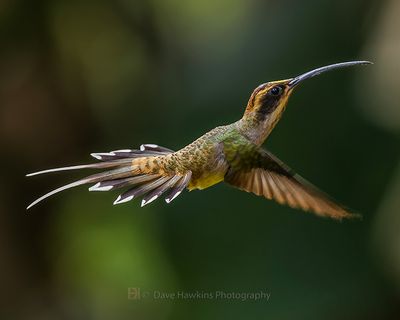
[0,0,400,319]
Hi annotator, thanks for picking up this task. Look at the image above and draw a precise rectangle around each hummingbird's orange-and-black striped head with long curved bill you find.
[243,61,372,141]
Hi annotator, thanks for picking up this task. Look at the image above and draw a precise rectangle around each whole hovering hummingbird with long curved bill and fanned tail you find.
[27,61,372,220]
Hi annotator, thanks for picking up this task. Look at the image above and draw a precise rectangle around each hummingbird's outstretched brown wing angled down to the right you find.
[225,147,358,219]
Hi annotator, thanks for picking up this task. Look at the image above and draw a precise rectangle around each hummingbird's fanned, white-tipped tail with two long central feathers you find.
[27,144,191,209]
